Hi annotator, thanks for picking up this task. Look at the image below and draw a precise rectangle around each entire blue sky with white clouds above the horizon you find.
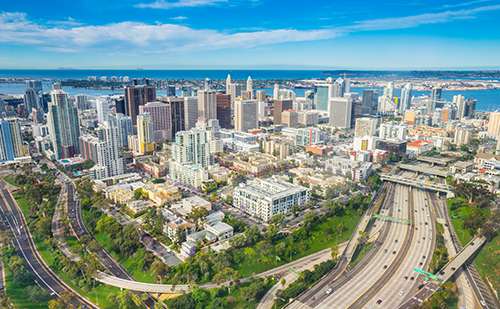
[0,0,500,69]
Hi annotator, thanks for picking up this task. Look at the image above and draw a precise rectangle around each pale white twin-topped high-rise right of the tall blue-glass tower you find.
[79,123,126,180]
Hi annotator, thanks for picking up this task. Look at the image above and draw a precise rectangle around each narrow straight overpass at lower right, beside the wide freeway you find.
[398,236,494,309]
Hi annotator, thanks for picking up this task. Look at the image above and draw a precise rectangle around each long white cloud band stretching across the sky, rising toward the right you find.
[0,4,500,55]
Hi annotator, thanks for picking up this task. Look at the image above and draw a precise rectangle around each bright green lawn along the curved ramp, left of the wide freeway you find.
[231,209,361,277]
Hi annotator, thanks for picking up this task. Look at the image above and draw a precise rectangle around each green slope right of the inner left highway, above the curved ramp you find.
[94,232,156,283]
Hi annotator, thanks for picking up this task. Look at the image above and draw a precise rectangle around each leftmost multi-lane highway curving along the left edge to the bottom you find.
[0,180,98,309]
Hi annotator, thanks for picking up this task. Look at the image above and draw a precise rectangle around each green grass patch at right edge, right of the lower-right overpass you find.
[474,235,500,295]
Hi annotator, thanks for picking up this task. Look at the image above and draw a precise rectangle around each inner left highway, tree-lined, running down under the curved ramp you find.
[65,181,155,309]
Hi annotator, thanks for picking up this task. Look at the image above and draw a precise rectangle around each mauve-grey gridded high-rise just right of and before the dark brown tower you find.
[139,102,172,142]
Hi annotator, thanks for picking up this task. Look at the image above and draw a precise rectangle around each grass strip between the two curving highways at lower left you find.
[34,238,137,309]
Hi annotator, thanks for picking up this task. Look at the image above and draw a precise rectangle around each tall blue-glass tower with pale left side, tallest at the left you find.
[47,90,80,160]
